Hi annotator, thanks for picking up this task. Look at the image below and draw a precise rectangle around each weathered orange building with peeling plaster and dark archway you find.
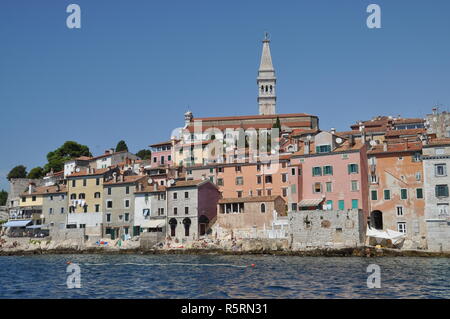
[367,140,426,249]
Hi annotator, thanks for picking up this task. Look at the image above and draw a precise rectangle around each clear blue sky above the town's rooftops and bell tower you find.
[0,0,450,188]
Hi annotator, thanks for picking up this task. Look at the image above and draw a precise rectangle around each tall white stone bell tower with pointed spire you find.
[256,32,277,115]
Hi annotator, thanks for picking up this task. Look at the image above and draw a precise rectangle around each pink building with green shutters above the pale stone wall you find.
[289,132,369,216]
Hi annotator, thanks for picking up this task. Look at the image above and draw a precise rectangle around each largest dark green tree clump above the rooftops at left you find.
[44,141,92,174]
